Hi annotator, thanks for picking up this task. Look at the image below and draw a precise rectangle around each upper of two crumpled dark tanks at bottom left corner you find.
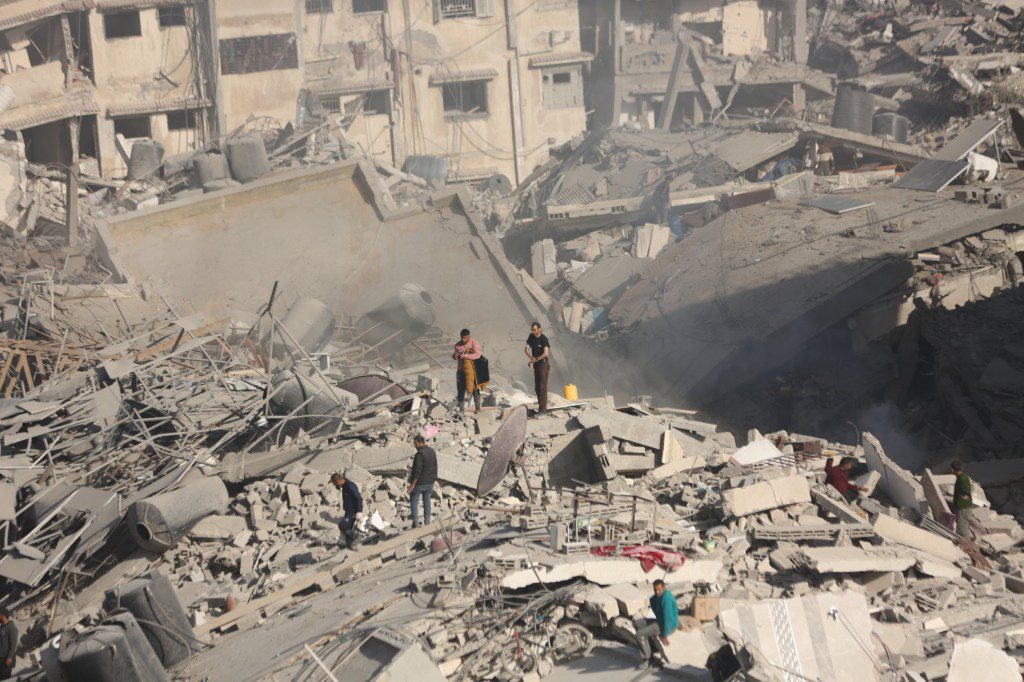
[103,570,199,668]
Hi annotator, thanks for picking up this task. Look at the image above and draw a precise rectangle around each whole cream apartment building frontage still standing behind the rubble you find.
[0,0,592,186]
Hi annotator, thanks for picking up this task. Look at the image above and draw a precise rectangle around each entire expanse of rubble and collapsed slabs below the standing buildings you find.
[0,2,1024,682]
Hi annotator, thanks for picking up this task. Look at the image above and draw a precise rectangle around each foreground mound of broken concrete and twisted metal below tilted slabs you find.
[0,258,1024,680]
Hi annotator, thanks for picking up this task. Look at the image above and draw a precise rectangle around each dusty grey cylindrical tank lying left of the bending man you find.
[128,476,227,552]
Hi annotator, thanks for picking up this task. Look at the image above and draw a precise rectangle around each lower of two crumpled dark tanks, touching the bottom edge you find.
[59,611,168,682]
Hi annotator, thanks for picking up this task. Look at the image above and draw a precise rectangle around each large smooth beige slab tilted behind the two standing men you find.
[96,162,543,368]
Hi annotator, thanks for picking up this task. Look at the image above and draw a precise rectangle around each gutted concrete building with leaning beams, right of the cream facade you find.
[581,0,815,129]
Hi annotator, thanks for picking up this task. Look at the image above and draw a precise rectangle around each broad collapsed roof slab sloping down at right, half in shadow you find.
[608,187,1024,397]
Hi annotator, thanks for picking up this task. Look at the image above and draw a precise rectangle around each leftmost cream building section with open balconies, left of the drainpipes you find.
[0,0,212,176]
